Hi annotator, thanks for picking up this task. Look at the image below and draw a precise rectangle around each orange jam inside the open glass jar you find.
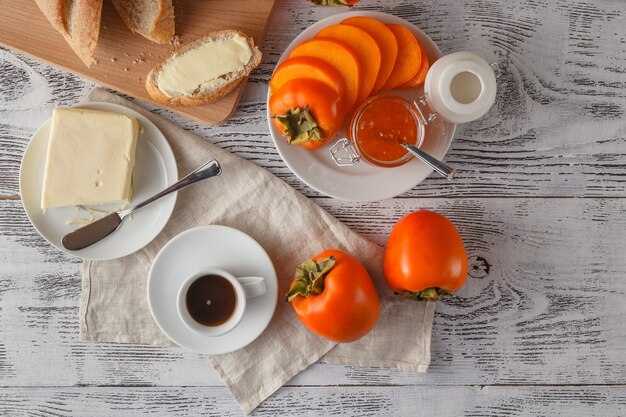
[350,96,419,167]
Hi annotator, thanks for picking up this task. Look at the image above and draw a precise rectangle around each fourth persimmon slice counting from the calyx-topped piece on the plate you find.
[341,16,398,93]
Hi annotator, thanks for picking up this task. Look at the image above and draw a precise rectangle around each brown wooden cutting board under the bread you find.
[0,0,274,124]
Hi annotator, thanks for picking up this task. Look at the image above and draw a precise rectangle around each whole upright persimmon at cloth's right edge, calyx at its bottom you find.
[384,210,468,301]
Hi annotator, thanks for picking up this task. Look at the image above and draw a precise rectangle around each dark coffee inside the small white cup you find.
[185,274,237,326]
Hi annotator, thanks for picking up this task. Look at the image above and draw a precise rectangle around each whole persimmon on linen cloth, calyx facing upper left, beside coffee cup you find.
[287,249,380,343]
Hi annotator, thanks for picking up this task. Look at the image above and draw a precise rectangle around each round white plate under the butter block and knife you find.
[20,103,178,260]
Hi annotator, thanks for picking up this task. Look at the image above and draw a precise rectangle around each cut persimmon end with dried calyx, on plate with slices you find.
[269,78,345,149]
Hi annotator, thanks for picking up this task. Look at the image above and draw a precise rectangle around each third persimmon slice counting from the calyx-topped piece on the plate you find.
[315,25,380,104]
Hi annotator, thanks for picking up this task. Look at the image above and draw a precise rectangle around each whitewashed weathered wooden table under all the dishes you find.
[0,0,626,416]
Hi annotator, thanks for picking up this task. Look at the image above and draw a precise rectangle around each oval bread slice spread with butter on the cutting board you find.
[146,29,262,106]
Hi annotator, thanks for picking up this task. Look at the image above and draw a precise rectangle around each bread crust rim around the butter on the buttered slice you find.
[146,29,262,106]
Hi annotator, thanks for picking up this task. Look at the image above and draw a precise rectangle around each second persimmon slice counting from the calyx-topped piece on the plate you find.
[289,38,362,111]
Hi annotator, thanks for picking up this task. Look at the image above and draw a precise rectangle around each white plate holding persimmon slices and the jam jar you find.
[267,12,456,201]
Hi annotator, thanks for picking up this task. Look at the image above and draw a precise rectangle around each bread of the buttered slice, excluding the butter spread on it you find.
[146,29,262,106]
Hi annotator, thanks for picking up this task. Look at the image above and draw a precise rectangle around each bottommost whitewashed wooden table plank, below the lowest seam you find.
[0,386,626,417]
